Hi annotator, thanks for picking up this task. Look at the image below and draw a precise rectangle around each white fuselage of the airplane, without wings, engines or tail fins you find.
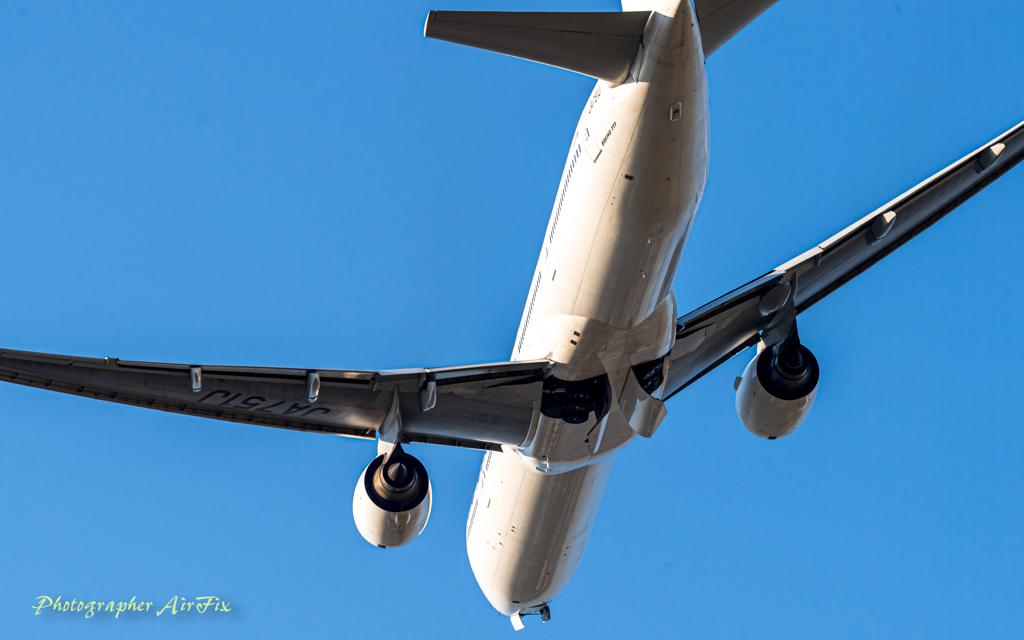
[466,0,709,615]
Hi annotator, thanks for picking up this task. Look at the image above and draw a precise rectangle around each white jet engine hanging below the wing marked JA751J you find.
[352,444,430,549]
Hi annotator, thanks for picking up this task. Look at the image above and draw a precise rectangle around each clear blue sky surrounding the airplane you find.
[0,0,1024,639]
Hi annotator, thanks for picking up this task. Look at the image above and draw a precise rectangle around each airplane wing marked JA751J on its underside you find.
[0,350,551,451]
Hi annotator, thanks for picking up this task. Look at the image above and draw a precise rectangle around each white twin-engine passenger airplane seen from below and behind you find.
[0,0,1024,630]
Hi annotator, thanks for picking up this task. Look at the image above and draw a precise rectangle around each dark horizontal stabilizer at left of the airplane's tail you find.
[423,11,650,84]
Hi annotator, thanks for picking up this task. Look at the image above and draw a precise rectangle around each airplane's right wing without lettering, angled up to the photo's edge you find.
[663,114,1024,398]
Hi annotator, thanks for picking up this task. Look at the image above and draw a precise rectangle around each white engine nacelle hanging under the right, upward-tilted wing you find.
[736,341,819,440]
